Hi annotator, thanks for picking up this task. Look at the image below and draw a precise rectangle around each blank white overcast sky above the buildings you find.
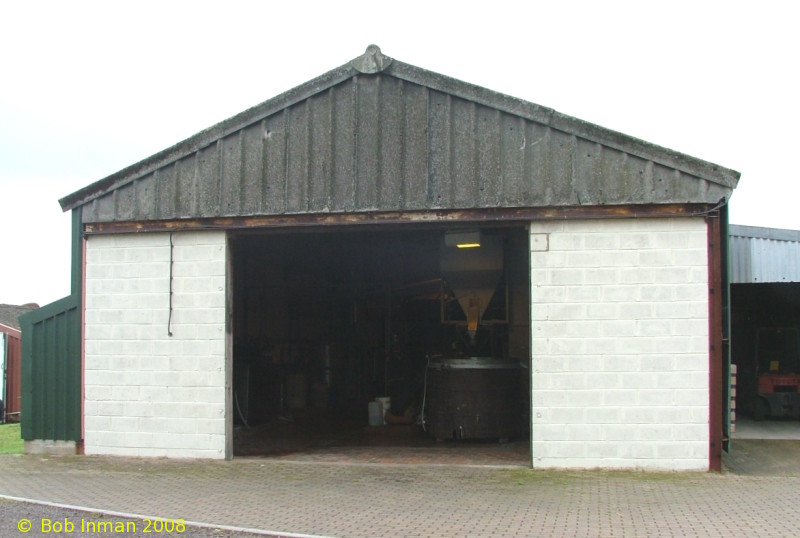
[0,0,800,305]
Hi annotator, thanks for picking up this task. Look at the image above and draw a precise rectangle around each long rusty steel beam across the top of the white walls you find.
[84,204,715,234]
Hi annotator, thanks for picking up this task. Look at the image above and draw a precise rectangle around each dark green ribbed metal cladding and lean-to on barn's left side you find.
[20,208,83,448]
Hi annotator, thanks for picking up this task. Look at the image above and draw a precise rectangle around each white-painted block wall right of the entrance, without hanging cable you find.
[531,218,709,470]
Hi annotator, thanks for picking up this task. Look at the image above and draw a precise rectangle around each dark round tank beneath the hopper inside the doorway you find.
[425,357,524,440]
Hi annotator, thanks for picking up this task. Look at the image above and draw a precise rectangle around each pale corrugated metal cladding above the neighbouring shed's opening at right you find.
[728,225,800,284]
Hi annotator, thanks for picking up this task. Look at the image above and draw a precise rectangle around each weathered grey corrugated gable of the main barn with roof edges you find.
[60,46,739,223]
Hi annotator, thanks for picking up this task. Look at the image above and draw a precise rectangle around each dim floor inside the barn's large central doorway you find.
[234,410,530,467]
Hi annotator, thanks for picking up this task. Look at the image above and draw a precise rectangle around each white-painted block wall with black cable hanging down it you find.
[84,231,226,458]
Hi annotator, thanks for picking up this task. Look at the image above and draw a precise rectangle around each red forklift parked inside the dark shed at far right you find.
[753,328,800,420]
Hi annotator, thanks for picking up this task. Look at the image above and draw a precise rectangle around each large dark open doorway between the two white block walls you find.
[230,225,531,465]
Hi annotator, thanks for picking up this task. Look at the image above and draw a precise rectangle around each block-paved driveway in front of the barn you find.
[0,445,800,537]
